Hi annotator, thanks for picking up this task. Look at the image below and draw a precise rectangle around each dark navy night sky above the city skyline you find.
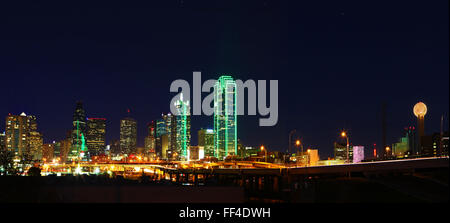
[0,0,449,159]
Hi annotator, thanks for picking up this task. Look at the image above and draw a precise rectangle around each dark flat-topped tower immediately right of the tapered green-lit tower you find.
[86,118,106,156]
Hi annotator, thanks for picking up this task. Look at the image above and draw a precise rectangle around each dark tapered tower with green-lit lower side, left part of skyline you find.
[68,102,89,161]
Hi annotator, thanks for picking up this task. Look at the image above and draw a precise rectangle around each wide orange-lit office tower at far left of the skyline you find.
[5,112,30,158]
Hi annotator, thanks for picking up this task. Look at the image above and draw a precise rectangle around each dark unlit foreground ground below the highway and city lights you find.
[0,170,449,203]
